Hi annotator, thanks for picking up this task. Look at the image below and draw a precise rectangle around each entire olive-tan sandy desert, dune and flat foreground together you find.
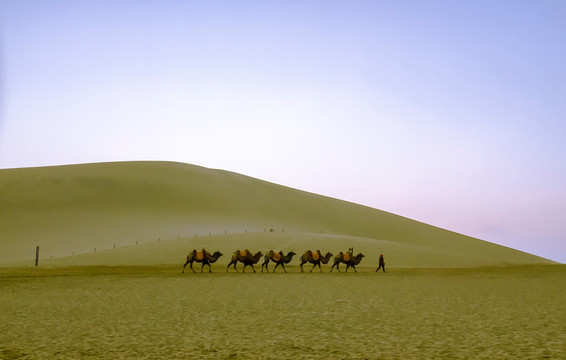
[0,162,566,359]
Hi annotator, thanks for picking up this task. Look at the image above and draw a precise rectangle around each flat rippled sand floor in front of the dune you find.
[0,264,566,359]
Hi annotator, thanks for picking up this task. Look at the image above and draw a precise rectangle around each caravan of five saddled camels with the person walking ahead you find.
[182,248,385,273]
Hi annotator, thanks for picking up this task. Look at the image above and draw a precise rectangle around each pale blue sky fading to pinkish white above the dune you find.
[0,0,566,263]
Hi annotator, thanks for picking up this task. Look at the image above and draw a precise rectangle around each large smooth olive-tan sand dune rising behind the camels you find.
[0,162,552,267]
